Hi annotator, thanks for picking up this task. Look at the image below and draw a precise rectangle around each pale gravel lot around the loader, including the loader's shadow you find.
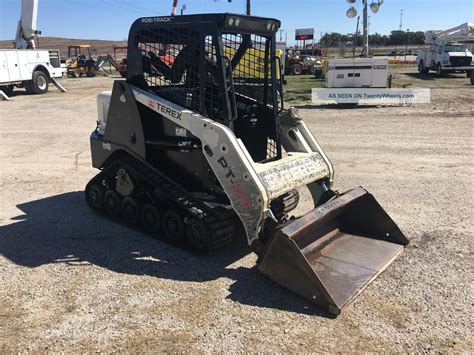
[0,73,474,352]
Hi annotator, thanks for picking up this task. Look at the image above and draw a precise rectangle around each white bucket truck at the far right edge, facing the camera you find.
[416,23,474,76]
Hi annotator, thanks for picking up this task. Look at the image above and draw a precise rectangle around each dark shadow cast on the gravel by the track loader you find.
[0,192,331,317]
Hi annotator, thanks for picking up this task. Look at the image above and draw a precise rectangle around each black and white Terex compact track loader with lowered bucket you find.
[85,14,408,314]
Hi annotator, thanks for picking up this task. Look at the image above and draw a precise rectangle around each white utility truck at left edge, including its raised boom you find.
[0,0,66,99]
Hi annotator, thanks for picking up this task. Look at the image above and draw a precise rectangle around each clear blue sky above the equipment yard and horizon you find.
[0,0,474,43]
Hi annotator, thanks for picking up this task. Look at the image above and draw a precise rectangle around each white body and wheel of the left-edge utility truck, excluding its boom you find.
[0,49,67,98]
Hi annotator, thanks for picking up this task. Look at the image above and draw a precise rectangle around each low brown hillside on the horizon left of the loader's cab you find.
[0,37,127,57]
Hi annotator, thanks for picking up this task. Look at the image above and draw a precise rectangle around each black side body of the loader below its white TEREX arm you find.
[91,80,209,191]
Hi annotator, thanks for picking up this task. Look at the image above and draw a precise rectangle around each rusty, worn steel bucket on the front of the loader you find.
[259,188,408,315]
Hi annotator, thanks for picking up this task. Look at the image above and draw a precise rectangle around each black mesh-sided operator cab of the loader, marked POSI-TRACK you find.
[127,14,281,162]
